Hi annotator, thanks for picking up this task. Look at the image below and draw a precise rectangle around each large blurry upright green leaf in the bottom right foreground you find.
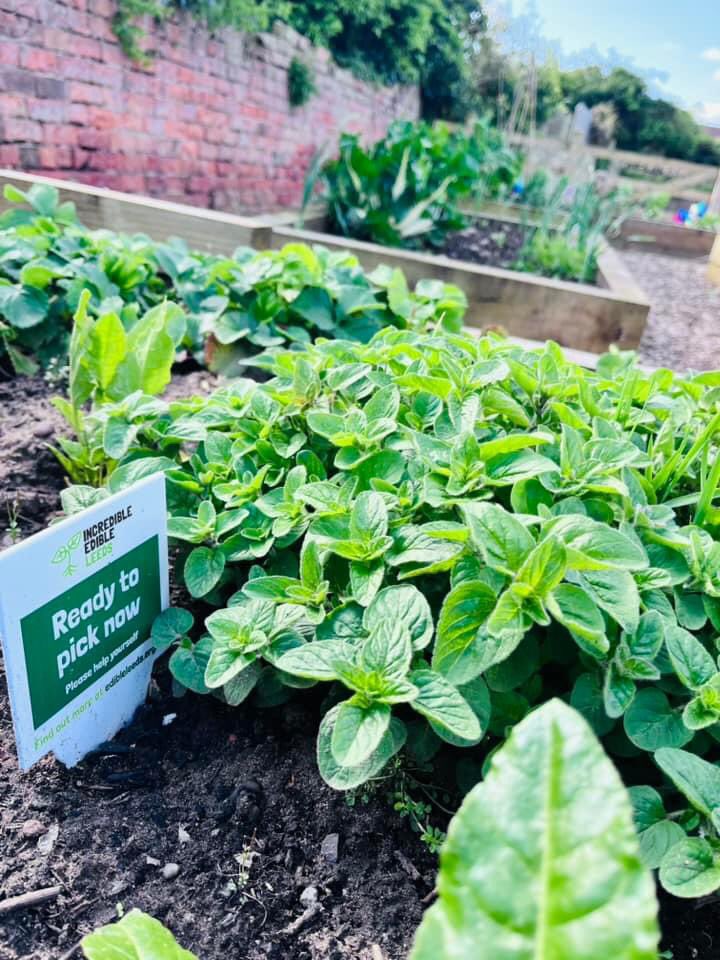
[410,700,659,960]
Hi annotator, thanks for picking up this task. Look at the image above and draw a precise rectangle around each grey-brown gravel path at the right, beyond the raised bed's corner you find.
[622,252,720,370]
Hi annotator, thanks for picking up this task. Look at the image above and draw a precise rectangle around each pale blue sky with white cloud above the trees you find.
[489,0,720,126]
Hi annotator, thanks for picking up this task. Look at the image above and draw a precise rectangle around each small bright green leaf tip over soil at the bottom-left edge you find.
[81,910,197,960]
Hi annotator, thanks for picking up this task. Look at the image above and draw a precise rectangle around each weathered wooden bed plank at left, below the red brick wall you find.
[0,169,271,254]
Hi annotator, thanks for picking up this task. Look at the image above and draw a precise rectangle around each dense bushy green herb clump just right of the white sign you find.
[60,328,720,808]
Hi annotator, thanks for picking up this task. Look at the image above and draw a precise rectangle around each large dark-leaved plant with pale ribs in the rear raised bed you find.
[321,121,519,247]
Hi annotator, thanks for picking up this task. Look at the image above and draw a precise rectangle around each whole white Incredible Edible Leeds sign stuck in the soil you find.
[0,474,168,770]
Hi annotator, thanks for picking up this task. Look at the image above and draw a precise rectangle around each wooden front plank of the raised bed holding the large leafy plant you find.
[272,227,650,353]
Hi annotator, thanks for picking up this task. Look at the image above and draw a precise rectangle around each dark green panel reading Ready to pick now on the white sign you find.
[20,536,162,729]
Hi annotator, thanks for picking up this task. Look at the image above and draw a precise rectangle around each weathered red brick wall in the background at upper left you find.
[0,0,419,212]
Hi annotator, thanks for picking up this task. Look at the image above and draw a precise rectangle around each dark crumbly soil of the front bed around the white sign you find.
[0,373,720,960]
